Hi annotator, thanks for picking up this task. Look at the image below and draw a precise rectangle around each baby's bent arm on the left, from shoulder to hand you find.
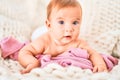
[18,35,44,73]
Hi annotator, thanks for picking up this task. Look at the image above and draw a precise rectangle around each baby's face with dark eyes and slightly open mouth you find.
[48,7,82,45]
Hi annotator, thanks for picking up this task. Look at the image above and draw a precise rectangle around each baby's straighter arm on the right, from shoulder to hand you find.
[80,40,108,72]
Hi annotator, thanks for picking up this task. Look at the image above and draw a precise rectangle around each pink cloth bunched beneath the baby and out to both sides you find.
[0,37,118,70]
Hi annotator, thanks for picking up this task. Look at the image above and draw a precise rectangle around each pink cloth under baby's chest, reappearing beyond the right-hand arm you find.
[39,48,118,70]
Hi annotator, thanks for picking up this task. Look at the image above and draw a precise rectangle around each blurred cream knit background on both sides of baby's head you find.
[0,0,120,55]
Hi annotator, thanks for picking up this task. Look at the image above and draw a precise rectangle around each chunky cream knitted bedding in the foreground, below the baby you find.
[0,55,120,80]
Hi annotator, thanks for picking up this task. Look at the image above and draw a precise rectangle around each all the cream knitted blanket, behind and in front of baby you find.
[0,0,120,80]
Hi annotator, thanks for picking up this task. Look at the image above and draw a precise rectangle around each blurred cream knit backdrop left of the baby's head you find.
[0,0,45,41]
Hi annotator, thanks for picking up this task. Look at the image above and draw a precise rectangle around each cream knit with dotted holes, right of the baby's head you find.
[82,0,120,57]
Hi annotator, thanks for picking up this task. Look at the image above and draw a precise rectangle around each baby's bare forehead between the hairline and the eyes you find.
[51,7,82,20]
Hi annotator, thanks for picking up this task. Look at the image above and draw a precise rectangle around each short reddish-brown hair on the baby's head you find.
[47,0,82,19]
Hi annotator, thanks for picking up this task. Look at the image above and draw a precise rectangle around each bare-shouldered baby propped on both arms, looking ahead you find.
[18,0,107,73]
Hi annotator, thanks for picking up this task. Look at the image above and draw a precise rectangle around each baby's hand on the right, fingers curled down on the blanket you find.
[93,64,108,73]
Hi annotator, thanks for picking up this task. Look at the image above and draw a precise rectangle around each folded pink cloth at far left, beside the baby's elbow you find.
[0,36,26,60]
